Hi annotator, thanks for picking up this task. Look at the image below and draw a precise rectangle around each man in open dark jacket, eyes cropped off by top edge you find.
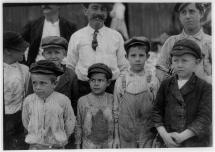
[22,4,76,66]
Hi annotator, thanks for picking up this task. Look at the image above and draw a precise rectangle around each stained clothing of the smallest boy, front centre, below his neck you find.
[76,93,114,148]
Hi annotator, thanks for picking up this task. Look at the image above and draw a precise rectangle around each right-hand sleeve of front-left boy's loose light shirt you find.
[64,99,76,137]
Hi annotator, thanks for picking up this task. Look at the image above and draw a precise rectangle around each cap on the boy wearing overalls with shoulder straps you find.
[124,36,150,53]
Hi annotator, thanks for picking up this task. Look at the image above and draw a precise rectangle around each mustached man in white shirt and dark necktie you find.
[66,3,128,95]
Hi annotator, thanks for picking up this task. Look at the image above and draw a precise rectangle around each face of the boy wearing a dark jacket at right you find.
[172,54,200,79]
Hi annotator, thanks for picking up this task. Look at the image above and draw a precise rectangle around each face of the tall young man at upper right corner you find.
[179,3,202,29]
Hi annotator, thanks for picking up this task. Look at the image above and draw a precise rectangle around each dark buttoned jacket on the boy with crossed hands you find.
[152,74,212,147]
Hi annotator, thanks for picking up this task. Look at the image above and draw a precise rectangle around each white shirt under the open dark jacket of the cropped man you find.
[36,19,60,61]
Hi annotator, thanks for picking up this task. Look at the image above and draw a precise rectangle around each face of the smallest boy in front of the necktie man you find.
[89,73,110,95]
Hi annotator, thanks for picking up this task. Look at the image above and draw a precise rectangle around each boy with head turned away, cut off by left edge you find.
[3,31,30,150]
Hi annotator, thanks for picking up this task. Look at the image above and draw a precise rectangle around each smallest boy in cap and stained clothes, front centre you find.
[76,63,114,149]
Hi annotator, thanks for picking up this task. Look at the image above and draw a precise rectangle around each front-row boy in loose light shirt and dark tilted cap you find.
[22,60,75,150]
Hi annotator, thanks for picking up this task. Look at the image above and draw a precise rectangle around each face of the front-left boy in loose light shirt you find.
[31,74,56,99]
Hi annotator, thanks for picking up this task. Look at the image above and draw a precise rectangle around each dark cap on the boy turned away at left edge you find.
[3,31,29,52]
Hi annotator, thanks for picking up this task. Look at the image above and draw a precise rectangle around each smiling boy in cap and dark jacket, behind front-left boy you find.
[28,36,78,114]
